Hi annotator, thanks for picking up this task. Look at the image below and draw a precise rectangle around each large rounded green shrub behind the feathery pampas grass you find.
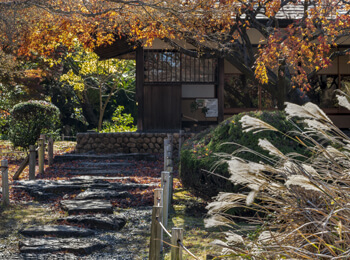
[180,111,306,200]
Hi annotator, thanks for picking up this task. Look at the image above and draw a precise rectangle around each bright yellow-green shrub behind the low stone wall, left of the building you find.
[100,106,137,133]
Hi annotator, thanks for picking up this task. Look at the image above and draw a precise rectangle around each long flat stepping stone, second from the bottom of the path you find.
[20,225,95,237]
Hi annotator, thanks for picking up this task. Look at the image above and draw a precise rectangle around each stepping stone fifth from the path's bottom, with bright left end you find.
[75,189,132,200]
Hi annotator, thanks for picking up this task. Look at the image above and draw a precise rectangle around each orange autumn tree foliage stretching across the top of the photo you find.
[0,0,350,105]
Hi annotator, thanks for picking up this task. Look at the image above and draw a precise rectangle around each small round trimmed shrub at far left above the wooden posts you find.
[9,100,60,149]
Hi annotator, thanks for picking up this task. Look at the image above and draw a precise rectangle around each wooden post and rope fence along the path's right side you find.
[149,133,199,260]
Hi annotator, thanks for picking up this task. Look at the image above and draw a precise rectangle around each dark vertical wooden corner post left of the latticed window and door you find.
[136,47,145,131]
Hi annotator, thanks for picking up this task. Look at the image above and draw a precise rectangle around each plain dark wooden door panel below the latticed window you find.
[144,84,181,131]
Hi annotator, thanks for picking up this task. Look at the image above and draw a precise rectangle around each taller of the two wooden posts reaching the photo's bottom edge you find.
[149,206,163,260]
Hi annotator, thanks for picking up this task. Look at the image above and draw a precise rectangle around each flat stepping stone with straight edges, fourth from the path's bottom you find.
[60,200,113,215]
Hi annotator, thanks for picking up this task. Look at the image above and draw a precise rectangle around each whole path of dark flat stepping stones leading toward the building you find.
[13,154,158,255]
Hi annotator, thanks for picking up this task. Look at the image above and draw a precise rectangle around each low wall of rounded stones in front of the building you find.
[76,133,191,154]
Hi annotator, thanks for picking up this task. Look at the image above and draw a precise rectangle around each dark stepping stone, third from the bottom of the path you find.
[58,214,126,231]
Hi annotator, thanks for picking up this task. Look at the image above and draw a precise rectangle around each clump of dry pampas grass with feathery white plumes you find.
[206,99,350,259]
